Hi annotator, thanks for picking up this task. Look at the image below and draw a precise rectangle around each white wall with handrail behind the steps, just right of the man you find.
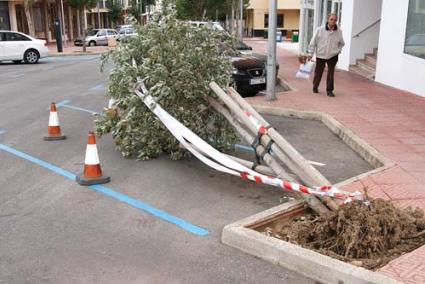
[338,0,382,70]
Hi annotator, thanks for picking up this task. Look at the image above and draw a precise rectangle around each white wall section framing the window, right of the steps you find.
[375,0,425,97]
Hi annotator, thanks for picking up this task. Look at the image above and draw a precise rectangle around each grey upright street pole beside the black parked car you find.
[266,0,277,101]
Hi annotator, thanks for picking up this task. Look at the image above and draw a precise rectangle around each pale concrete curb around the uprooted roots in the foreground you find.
[221,201,400,284]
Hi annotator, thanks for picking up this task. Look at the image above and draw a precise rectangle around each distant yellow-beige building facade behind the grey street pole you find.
[245,0,300,37]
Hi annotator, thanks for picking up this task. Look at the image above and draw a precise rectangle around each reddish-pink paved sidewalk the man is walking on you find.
[245,39,425,283]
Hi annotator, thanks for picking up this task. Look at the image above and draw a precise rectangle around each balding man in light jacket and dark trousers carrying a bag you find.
[308,14,345,97]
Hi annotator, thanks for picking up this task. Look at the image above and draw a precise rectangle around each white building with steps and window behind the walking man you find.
[300,0,425,97]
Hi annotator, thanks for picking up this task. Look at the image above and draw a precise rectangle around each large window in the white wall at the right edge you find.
[404,0,425,59]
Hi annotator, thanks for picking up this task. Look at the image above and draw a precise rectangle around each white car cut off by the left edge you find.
[0,30,49,64]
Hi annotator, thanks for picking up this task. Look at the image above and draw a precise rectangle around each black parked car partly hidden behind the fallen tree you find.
[232,41,279,97]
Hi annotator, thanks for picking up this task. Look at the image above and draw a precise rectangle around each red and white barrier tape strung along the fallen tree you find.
[135,83,363,203]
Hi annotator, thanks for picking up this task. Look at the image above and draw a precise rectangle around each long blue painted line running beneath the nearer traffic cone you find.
[0,144,209,236]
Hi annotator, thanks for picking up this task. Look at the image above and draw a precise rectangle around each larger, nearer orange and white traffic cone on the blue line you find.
[75,131,111,185]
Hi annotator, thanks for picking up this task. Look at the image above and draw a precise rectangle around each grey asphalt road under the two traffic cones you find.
[0,56,313,283]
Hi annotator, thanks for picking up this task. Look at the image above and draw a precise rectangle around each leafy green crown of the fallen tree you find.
[96,5,237,160]
